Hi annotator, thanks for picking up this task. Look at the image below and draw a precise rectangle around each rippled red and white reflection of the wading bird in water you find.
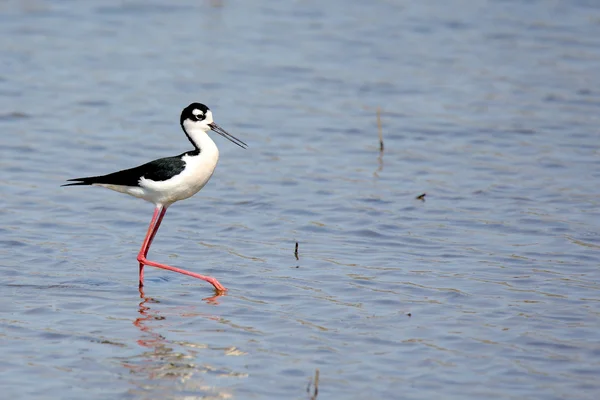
[122,288,240,399]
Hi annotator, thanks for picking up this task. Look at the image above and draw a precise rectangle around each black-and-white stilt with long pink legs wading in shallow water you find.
[62,103,248,293]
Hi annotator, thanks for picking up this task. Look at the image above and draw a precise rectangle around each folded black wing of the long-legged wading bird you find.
[62,153,186,186]
